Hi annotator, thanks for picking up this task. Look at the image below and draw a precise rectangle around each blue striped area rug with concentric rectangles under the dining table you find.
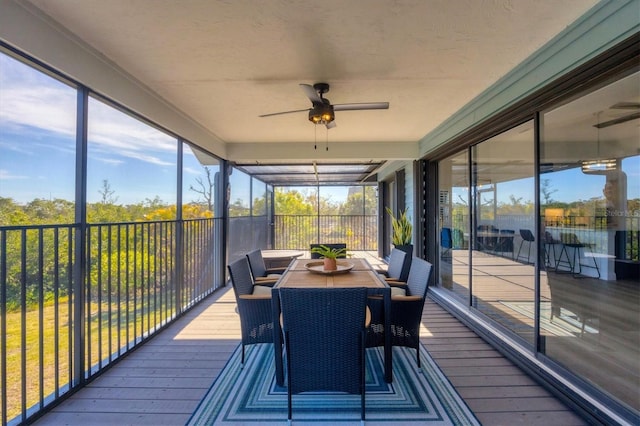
[187,344,480,426]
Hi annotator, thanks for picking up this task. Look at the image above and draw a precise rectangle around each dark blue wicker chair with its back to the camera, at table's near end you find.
[279,287,367,421]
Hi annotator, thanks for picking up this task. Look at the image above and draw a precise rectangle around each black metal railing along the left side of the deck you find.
[0,219,217,425]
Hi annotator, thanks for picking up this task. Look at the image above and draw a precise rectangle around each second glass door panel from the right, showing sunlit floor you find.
[469,121,537,345]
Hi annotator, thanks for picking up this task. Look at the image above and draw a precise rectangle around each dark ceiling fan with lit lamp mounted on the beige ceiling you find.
[259,83,389,129]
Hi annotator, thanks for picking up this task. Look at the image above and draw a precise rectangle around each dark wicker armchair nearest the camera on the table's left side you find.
[227,257,273,364]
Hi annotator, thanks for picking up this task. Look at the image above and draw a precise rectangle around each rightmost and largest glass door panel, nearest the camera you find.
[540,73,640,412]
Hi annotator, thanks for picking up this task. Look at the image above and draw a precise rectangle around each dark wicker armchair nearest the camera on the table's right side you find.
[367,256,432,367]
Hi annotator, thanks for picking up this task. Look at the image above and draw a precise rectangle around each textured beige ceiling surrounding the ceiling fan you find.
[21,0,597,180]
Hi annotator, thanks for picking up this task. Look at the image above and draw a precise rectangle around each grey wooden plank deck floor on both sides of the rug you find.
[36,255,586,426]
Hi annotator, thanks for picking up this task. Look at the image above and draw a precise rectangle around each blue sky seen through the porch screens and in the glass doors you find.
[0,50,640,204]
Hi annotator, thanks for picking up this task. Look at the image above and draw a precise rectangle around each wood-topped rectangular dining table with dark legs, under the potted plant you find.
[271,258,393,386]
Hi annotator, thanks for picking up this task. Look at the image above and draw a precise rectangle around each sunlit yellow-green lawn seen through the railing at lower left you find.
[6,297,173,420]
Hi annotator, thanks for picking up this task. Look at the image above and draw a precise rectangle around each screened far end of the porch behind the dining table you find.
[228,173,378,261]
